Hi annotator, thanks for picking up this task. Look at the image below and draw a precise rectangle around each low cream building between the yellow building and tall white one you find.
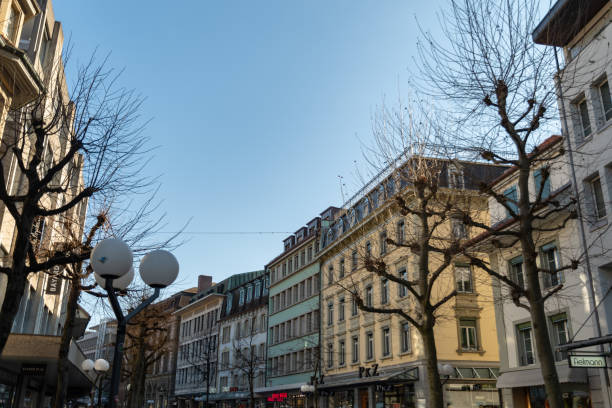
[479,136,598,407]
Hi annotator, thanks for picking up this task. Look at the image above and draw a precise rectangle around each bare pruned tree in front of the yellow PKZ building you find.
[330,97,506,408]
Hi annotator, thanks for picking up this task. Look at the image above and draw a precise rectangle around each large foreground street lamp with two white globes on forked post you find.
[91,239,179,408]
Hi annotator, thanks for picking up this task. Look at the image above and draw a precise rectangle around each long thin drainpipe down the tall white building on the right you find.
[553,46,612,407]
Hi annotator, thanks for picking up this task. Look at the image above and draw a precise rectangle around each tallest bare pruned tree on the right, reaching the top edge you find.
[396,0,608,408]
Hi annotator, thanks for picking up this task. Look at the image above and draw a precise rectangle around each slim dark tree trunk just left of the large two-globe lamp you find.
[53,275,81,408]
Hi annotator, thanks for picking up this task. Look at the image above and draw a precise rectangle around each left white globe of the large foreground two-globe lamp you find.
[90,238,134,279]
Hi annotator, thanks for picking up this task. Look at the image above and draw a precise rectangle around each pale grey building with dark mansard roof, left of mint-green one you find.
[215,270,268,408]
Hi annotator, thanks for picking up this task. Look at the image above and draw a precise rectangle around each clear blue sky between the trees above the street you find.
[54,0,462,289]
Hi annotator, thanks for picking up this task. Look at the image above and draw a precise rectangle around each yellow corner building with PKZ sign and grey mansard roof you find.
[319,159,504,408]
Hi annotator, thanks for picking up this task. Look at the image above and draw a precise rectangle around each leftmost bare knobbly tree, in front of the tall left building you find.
[0,49,152,351]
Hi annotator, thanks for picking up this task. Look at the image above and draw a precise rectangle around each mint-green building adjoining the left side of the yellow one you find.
[257,217,321,408]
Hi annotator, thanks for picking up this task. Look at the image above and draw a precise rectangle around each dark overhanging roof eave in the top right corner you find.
[531,0,608,47]
